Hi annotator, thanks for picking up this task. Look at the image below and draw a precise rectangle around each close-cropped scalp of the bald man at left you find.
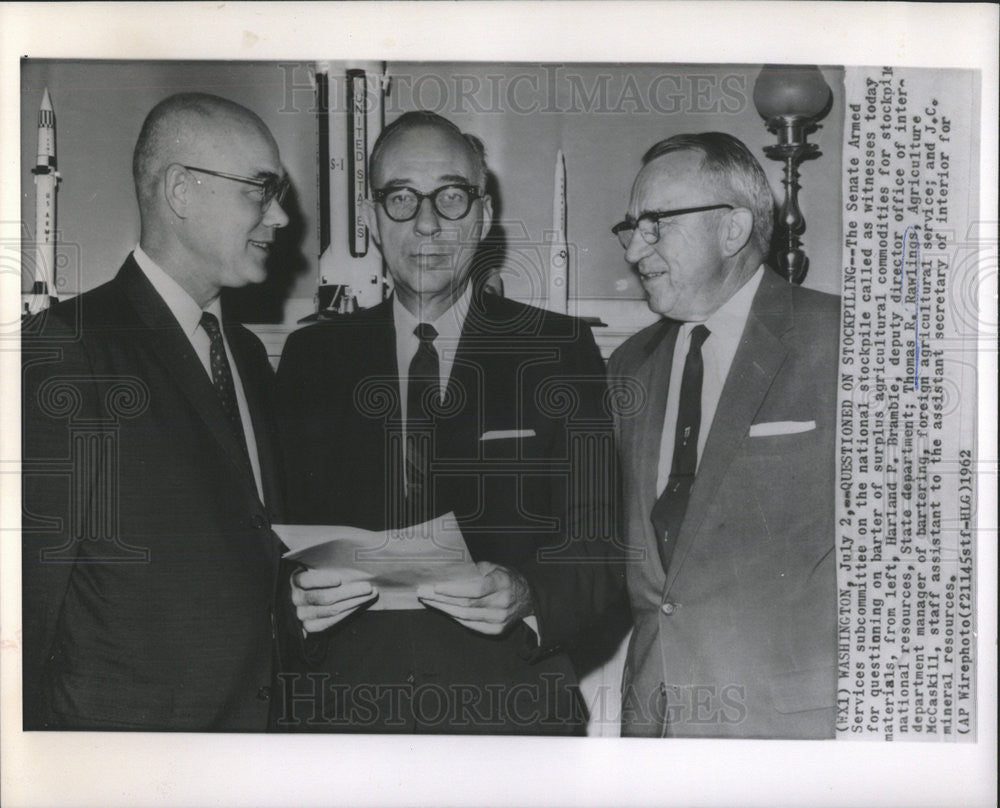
[132,93,277,216]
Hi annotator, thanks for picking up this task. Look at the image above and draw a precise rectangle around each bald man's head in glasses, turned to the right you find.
[132,93,288,308]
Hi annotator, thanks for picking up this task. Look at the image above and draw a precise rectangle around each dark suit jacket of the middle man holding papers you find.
[278,295,623,733]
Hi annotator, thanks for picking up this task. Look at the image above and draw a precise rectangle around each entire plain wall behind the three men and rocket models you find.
[21,60,843,355]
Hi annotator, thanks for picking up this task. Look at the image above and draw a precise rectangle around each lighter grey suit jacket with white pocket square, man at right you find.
[609,270,840,738]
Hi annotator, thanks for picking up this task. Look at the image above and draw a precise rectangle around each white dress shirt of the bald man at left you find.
[133,245,264,502]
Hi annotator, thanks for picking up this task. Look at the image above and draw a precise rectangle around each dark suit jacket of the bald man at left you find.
[22,256,279,730]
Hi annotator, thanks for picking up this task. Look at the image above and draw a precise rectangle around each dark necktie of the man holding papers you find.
[405,323,441,524]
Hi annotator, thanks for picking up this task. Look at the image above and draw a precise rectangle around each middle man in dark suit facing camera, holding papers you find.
[278,112,622,734]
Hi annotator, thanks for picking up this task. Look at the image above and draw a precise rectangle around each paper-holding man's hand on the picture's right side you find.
[417,561,534,634]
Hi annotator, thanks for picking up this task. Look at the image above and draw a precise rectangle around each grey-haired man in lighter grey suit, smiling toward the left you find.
[609,133,840,738]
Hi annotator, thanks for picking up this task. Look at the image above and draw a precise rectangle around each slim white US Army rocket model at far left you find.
[26,87,59,314]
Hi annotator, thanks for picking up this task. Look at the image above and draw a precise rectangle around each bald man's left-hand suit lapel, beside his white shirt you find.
[117,256,257,498]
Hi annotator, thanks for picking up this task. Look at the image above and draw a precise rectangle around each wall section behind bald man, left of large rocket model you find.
[21,60,318,323]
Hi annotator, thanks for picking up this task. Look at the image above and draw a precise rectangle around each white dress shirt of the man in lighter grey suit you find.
[656,265,764,494]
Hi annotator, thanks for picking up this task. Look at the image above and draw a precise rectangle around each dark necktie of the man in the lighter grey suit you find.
[650,325,709,572]
